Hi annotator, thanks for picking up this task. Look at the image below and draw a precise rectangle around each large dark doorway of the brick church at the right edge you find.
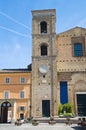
[77,94,86,116]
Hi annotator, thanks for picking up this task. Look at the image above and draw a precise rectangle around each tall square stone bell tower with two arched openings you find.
[31,9,57,117]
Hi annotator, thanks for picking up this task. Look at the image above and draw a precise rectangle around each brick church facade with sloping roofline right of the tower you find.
[56,27,86,115]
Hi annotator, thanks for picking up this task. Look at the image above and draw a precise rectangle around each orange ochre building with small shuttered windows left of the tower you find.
[0,69,31,123]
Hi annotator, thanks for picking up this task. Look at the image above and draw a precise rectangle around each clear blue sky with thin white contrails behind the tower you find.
[0,0,86,69]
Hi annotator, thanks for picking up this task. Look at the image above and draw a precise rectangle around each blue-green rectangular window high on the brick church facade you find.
[74,43,83,57]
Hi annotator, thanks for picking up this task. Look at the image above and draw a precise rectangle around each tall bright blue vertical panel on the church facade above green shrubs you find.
[60,81,68,104]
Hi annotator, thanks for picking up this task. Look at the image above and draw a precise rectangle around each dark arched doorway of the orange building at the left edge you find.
[1,101,12,123]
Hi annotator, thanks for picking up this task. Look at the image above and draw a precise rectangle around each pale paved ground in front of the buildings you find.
[0,123,86,130]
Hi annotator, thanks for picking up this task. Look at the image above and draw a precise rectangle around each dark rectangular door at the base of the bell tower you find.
[42,100,50,117]
